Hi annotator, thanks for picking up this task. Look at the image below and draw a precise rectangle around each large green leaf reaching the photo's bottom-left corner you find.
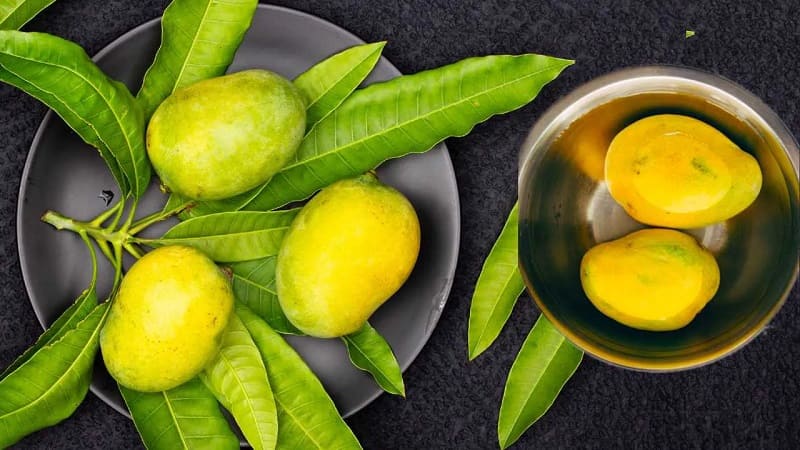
[0,303,108,448]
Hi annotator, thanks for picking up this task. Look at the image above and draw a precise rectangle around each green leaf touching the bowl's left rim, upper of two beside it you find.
[467,204,525,360]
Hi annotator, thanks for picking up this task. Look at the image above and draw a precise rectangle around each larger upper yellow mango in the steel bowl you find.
[605,114,762,228]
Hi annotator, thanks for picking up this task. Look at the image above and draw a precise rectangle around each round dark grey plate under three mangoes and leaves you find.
[17,5,460,416]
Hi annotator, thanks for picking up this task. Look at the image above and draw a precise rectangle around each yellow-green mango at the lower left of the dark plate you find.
[100,246,233,392]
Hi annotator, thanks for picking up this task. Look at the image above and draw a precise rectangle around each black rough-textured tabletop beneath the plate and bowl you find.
[0,0,800,449]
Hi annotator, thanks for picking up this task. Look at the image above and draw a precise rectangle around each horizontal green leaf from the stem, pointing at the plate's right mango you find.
[148,209,299,262]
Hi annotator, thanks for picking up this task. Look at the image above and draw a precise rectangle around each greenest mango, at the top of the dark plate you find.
[147,70,306,200]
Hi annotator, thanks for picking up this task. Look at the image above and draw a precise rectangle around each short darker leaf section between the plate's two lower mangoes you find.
[230,256,303,335]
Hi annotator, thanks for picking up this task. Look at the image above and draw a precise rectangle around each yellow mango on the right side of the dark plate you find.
[275,174,420,338]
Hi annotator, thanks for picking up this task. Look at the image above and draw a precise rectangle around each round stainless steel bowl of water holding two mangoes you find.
[519,66,800,371]
